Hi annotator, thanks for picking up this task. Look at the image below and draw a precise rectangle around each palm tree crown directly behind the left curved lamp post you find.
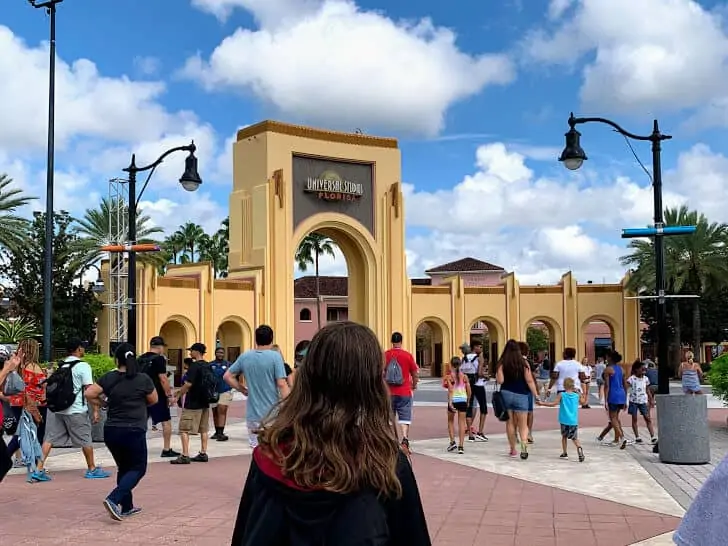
[71,197,166,269]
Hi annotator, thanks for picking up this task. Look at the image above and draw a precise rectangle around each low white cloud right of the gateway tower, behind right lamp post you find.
[404,139,728,283]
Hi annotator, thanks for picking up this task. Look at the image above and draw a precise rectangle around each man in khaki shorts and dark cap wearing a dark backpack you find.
[170,343,218,464]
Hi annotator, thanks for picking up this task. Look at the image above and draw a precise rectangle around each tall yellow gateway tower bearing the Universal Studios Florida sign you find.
[229,121,415,358]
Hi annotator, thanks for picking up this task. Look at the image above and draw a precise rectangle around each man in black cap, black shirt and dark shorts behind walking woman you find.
[137,336,179,458]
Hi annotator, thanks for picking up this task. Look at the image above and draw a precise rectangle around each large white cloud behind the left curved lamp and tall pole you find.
[0,26,232,226]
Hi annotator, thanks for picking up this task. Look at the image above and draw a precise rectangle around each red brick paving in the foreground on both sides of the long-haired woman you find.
[0,448,678,546]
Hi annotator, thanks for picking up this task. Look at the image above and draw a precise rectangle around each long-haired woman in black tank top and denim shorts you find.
[496,339,538,459]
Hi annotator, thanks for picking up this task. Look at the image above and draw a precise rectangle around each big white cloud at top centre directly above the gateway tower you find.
[183,0,514,136]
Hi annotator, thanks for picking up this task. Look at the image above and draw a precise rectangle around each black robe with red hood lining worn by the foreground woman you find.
[232,449,432,546]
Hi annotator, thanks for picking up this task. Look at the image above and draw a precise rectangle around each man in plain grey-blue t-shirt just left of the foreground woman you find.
[223,325,289,448]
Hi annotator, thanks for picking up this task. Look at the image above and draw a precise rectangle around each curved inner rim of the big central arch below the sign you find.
[290,212,383,332]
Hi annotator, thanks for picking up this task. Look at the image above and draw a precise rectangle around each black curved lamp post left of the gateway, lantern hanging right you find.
[124,142,202,347]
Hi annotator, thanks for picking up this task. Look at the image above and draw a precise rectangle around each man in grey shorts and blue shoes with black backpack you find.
[42,338,111,479]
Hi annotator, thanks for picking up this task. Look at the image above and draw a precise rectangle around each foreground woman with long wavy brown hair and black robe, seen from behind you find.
[232,322,431,546]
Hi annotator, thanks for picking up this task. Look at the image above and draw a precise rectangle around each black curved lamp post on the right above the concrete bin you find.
[559,113,677,394]
